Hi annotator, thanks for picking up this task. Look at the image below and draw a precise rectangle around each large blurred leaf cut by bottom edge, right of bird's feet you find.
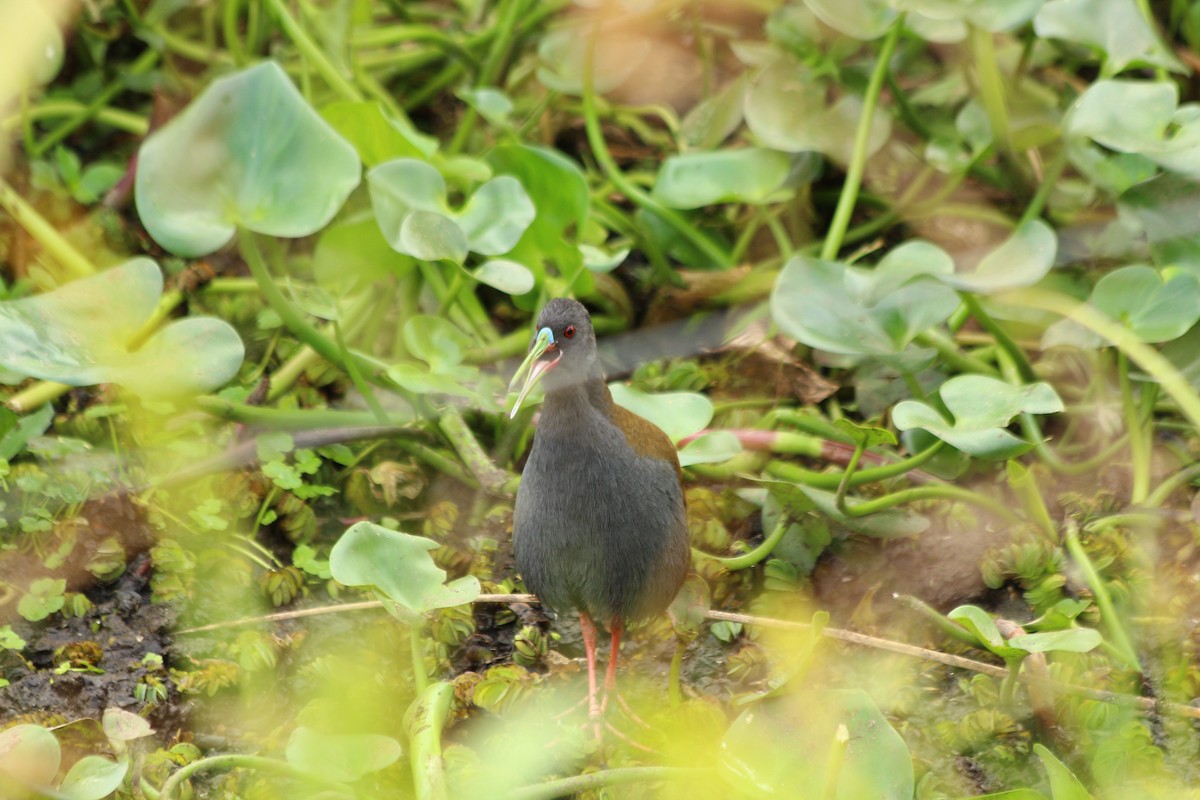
[718,690,913,800]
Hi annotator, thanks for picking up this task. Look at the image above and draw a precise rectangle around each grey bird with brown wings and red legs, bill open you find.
[510,297,691,735]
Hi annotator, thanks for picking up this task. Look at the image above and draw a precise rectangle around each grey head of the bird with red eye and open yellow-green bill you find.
[510,297,596,417]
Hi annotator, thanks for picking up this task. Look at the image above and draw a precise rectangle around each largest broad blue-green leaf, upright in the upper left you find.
[137,61,361,257]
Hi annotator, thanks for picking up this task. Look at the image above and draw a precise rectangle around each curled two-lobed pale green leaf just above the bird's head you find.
[367,158,536,264]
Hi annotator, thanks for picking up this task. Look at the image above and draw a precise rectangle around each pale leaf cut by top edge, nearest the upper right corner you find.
[1033,0,1186,76]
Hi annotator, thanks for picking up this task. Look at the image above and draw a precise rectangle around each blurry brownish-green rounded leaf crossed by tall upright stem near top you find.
[744,58,892,163]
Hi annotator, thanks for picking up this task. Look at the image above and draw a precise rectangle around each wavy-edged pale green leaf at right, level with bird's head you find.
[892,375,1063,459]
